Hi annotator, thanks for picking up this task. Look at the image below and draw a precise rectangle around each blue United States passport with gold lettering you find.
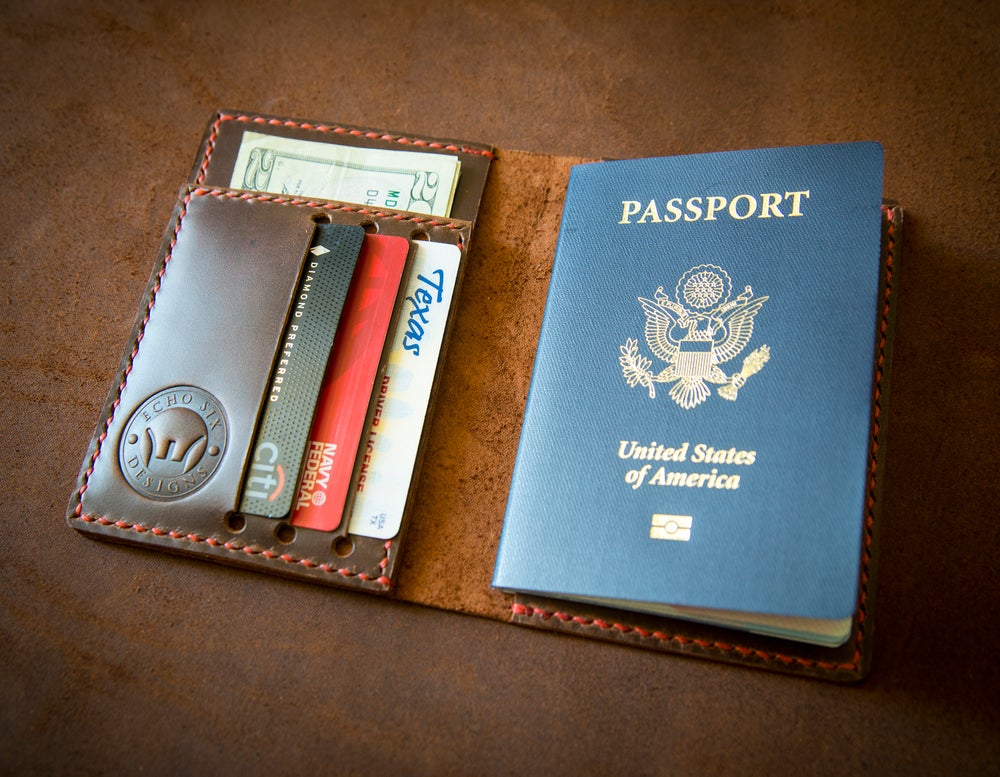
[493,143,882,646]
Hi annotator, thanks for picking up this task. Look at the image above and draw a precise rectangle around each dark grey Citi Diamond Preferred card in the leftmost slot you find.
[240,224,365,518]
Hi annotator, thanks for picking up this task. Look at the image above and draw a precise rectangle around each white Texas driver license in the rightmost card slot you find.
[349,241,461,539]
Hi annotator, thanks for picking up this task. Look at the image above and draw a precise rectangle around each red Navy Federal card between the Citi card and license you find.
[292,235,410,531]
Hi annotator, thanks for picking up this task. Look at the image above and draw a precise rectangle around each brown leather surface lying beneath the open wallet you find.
[0,0,1000,774]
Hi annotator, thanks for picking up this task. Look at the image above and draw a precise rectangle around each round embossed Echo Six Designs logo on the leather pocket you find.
[118,386,228,499]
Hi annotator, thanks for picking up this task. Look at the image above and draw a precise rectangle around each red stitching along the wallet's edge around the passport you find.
[510,206,896,671]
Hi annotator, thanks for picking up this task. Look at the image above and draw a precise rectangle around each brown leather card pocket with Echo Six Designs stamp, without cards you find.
[67,186,471,592]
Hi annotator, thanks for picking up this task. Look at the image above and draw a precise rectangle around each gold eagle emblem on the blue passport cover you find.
[618,264,771,410]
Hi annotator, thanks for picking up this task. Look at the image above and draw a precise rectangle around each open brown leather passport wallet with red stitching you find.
[67,111,901,681]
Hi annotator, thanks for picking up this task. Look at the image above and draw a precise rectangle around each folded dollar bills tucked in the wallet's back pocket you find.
[229,132,461,216]
